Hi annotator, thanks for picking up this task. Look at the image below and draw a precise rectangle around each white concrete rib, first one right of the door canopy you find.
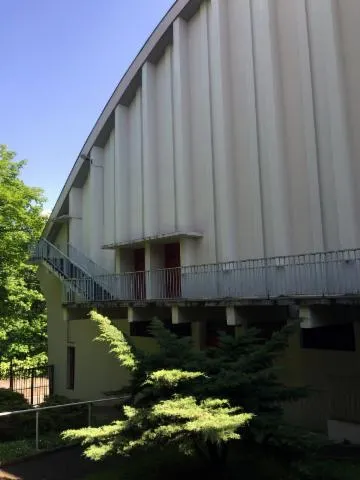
[210,0,238,261]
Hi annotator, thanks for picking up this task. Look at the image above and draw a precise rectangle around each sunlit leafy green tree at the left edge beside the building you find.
[0,145,46,362]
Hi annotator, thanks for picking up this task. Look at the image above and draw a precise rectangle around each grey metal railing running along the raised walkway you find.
[64,249,360,302]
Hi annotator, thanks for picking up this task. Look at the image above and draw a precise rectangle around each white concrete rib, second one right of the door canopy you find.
[250,0,290,256]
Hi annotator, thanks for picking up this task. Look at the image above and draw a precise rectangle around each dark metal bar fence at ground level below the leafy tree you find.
[4,365,54,405]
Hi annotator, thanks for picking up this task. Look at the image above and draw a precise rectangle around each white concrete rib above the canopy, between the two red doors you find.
[142,62,159,237]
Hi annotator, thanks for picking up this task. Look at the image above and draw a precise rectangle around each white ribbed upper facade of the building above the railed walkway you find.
[48,0,360,272]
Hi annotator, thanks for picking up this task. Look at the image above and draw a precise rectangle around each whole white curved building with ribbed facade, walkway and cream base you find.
[35,0,360,436]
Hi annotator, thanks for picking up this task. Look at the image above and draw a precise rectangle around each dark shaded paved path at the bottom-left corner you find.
[0,447,118,480]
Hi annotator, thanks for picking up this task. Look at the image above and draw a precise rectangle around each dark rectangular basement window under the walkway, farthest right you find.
[301,322,356,352]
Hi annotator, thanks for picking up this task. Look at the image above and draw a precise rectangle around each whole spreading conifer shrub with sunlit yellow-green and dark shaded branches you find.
[64,312,316,465]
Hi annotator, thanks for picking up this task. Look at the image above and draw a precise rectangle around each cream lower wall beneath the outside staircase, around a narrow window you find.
[38,265,159,400]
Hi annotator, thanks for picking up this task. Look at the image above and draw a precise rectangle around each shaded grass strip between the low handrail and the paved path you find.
[0,434,66,466]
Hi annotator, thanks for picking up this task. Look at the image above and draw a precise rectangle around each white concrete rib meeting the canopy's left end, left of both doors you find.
[115,105,130,242]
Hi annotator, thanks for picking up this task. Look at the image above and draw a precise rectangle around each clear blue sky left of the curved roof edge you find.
[0,0,173,208]
